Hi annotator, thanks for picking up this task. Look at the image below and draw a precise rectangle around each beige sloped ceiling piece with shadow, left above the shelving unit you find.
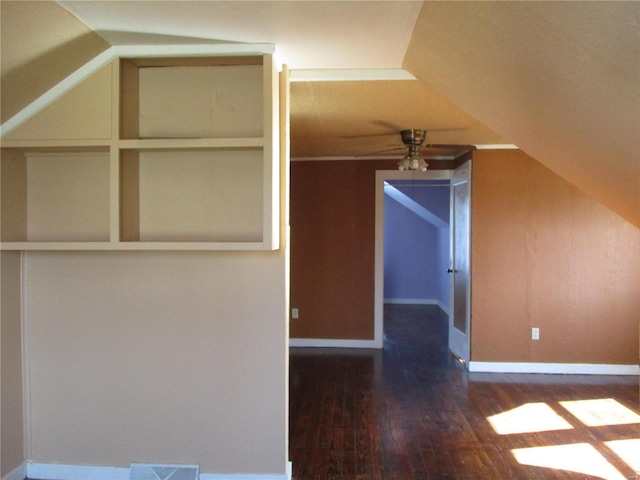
[0,0,109,123]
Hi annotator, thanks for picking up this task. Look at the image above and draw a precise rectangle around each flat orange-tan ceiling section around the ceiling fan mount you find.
[291,80,506,158]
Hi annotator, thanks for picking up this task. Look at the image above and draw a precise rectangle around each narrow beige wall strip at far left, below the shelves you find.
[0,252,25,478]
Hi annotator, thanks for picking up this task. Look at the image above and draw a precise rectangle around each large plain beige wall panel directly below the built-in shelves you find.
[26,252,288,474]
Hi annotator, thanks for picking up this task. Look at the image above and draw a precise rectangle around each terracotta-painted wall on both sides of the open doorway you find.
[291,151,640,364]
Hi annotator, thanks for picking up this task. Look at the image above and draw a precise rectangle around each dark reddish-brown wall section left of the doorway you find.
[290,160,396,340]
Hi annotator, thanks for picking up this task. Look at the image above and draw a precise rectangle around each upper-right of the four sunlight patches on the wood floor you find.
[560,398,640,427]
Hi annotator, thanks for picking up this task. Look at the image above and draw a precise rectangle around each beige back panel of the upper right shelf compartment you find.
[140,65,263,138]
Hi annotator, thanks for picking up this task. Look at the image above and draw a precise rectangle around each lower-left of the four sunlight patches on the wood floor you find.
[511,443,627,480]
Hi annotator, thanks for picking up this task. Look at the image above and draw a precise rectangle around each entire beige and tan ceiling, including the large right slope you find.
[1,0,640,226]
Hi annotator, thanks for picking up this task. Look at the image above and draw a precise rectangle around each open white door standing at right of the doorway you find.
[449,161,471,365]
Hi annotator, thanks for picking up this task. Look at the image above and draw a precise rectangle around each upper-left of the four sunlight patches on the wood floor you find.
[487,403,573,435]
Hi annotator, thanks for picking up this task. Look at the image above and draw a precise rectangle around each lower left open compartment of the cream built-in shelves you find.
[2,149,110,243]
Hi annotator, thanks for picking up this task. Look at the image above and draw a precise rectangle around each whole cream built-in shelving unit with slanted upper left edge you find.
[1,55,279,250]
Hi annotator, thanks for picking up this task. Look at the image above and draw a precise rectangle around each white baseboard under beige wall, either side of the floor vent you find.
[24,462,292,480]
